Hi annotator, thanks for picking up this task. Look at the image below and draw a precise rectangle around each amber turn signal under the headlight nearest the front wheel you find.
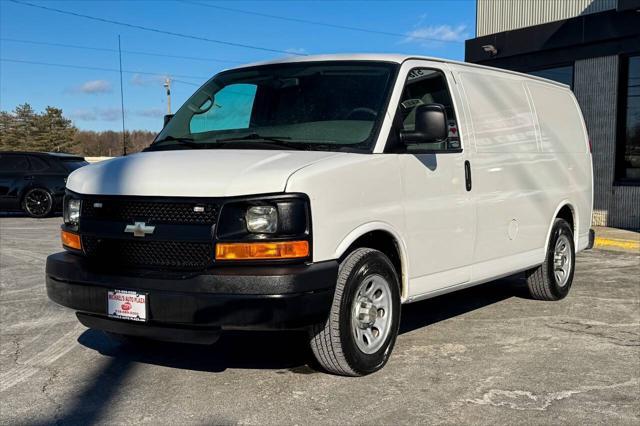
[216,241,309,260]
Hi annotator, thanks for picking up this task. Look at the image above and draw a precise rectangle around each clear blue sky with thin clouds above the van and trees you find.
[0,0,475,131]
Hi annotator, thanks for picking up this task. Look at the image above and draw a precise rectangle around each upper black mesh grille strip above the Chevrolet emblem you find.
[82,199,218,225]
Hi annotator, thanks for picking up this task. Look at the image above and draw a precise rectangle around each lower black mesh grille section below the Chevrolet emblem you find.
[82,235,213,269]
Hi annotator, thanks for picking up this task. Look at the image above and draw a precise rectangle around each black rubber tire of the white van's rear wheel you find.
[526,219,576,300]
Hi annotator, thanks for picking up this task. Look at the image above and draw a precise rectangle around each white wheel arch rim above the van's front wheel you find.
[334,222,409,302]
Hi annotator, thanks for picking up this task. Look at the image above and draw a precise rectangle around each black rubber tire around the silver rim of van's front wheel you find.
[310,248,400,376]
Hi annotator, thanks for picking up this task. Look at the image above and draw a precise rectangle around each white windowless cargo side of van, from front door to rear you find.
[456,66,592,282]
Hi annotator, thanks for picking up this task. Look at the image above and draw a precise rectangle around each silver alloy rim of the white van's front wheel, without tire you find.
[351,274,392,354]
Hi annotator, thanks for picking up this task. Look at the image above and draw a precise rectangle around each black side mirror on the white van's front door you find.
[400,104,449,145]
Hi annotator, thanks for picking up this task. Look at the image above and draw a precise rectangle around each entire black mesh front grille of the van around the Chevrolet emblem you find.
[80,197,220,270]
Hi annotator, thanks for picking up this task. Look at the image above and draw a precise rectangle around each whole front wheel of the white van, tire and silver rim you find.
[311,248,400,376]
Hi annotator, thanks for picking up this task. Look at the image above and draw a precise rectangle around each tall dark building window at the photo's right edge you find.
[617,55,640,184]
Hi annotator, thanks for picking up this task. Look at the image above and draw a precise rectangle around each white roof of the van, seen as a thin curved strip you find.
[233,53,569,89]
